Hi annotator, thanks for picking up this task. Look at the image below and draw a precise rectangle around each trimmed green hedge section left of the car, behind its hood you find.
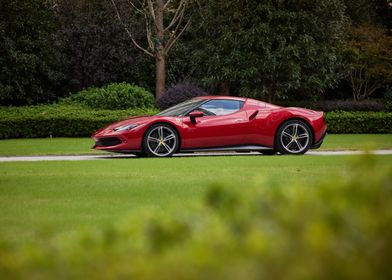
[0,105,156,139]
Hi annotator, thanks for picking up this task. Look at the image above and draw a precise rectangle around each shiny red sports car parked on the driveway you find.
[92,96,327,157]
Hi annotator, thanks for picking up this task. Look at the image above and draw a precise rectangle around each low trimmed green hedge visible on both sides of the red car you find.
[0,105,392,139]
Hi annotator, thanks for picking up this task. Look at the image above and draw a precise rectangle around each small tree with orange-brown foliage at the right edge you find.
[346,25,392,101]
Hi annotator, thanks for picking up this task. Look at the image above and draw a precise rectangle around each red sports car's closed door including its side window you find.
[182,99,249,149]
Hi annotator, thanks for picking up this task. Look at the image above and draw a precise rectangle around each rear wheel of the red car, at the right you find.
[275,120,313,155]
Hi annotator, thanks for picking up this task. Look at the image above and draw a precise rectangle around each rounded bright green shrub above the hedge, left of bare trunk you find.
[63,83,154,109]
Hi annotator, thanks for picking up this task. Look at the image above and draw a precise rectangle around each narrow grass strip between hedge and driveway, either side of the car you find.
[0,134,392,156]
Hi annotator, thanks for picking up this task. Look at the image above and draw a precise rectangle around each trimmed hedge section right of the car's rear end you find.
[326,111,392,133]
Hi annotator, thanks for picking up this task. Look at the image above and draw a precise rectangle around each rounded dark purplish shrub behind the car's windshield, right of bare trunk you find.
[157,84,208,110]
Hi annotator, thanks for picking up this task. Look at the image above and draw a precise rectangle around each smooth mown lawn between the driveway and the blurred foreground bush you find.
[0,156,392,243]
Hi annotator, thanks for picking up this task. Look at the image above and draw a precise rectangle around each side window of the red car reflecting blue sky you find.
[199,99,244,116]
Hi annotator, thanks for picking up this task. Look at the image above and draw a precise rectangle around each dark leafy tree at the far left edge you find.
[0,0,62,105]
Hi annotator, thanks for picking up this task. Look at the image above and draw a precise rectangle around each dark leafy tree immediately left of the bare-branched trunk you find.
[54,0,153,93]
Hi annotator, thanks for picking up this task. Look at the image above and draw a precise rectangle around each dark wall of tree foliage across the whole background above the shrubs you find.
[0,0,392,105]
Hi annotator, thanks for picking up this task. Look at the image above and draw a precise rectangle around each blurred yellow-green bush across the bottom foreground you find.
[0,155,392,280]
